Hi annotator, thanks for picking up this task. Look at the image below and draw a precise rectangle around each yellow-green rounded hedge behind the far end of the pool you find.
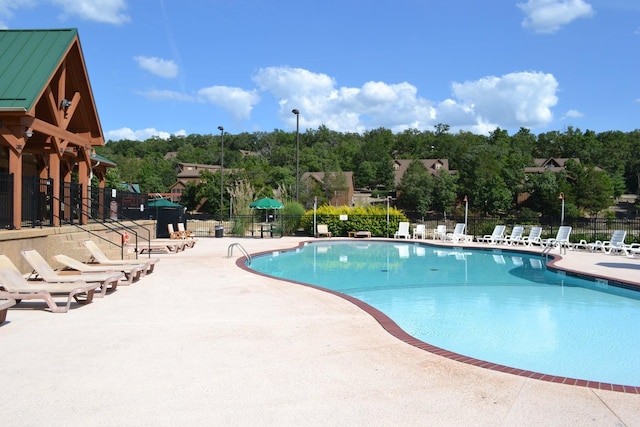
[300,205,409,237]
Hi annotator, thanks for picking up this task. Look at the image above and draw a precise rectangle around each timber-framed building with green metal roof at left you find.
[0,28,114,228]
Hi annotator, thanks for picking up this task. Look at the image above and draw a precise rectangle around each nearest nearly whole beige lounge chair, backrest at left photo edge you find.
[0,255,100,313]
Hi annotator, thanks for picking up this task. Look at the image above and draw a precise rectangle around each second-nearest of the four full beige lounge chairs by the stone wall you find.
[21,249,124,298]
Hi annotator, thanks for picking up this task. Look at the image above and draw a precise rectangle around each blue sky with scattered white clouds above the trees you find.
[0,0,640,140]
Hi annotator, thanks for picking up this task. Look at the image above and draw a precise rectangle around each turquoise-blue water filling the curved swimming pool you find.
[250,241,640,386]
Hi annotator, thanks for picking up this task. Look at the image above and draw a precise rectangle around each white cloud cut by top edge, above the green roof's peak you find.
[51,0,131,25]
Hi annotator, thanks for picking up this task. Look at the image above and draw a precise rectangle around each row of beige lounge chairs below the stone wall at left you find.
[0,240,159,323]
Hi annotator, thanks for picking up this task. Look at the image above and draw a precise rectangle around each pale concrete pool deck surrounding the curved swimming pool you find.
[0,237,640,426]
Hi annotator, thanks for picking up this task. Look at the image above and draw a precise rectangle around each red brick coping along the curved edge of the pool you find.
[236,242,640,394]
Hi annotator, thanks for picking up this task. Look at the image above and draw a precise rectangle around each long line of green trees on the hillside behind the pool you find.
[97,124,640,215]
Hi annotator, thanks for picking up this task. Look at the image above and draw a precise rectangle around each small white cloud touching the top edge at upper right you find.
[517,0,594,33]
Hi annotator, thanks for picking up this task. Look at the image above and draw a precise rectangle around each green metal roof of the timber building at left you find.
[0,28,78,111]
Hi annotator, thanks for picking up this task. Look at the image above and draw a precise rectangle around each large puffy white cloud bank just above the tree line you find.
[253,67,558,134]
